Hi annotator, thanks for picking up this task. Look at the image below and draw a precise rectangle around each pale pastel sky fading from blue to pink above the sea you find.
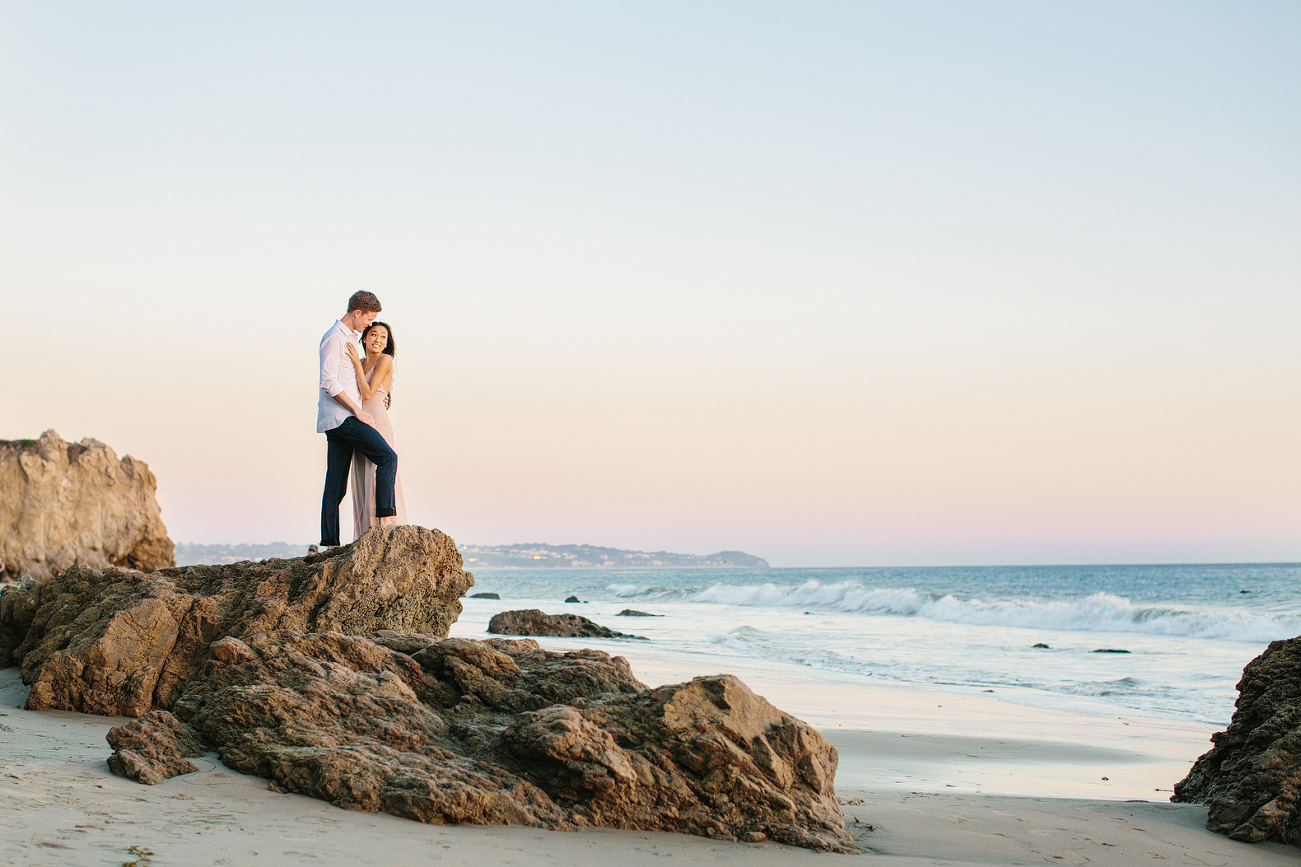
[0,0,1301,565]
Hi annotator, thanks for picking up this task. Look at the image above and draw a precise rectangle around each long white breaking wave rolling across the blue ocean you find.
[681,581,1301,642]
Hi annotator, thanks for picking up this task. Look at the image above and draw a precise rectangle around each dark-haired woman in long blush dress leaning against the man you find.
[347,322,407,538]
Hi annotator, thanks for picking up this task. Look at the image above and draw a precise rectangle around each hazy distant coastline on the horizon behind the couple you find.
[176,542,769,571]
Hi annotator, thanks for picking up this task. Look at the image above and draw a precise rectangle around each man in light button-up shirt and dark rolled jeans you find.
[316,292,398,548]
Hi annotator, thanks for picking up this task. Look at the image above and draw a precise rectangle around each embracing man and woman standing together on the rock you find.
[316,292,407,548]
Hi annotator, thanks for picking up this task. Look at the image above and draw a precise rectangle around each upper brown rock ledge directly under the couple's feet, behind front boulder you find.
[0,526,474,716]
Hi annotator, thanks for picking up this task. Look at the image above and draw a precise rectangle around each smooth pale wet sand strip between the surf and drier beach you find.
[468,621,1223,801]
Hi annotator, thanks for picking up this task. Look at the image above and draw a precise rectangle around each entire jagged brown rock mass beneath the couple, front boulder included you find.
[0,526,853,851]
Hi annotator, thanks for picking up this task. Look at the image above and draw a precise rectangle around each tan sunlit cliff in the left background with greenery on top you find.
[0,431,174,579]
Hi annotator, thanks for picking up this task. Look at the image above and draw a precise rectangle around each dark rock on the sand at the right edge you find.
[1171,638,1301,845]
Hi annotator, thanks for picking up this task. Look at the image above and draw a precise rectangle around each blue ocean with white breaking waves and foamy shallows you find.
[455,564,1301,728]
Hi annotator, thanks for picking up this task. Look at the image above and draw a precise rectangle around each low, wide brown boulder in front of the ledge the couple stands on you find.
[152,631,853,851]
